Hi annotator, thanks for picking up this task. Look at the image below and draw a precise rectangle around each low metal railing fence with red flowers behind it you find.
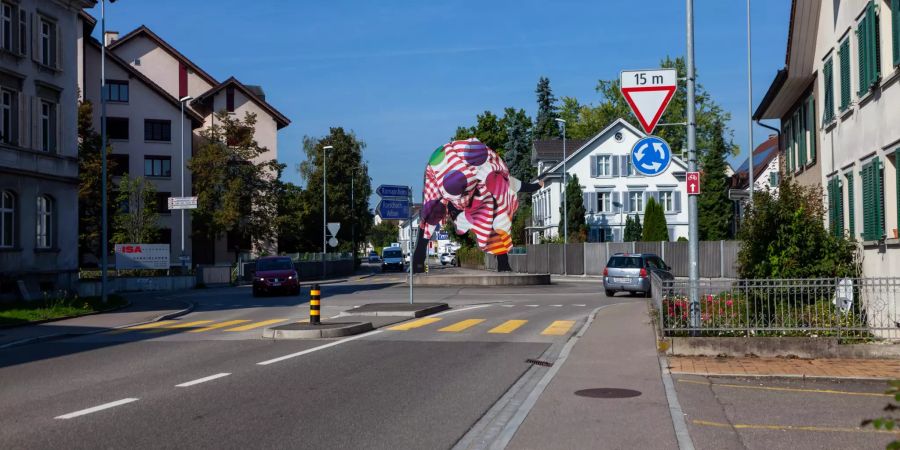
[653,276,900,340]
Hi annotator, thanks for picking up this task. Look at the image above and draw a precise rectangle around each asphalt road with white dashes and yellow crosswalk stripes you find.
[0,268,624,448]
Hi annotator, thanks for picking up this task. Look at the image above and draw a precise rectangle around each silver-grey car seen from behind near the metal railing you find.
[603,253,675,297]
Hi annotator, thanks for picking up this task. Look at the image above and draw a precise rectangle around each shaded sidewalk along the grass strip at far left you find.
[0,292,193,349]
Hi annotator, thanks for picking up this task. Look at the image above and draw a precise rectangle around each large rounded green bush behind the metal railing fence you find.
[738,177,859,279]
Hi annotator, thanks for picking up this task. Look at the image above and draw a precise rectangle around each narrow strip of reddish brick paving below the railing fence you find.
[668,356,900,380]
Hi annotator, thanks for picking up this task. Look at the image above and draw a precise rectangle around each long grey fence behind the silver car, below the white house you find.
[486,241,741,278]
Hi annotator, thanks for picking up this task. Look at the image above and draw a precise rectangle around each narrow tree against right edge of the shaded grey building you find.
[78,101,116,261]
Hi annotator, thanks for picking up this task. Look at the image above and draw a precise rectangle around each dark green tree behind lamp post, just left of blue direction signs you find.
[298,127,373,252]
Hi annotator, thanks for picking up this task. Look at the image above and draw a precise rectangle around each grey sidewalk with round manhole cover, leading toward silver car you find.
[507,301,678,449]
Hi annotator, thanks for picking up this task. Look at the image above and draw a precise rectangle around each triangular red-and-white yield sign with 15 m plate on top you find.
[620,69,678,134]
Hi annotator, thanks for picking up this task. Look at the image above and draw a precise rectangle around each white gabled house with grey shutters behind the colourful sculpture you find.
[532,119,688,242]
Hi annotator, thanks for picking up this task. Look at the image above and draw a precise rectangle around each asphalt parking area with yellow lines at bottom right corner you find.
[673,374,898,450]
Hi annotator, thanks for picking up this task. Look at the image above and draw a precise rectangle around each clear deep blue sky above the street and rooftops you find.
[89,0,791,207]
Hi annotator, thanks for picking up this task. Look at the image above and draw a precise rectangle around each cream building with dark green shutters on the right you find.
[756,0,900,276]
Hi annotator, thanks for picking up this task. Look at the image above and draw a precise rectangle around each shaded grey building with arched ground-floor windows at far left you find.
[0,0,96,297]
